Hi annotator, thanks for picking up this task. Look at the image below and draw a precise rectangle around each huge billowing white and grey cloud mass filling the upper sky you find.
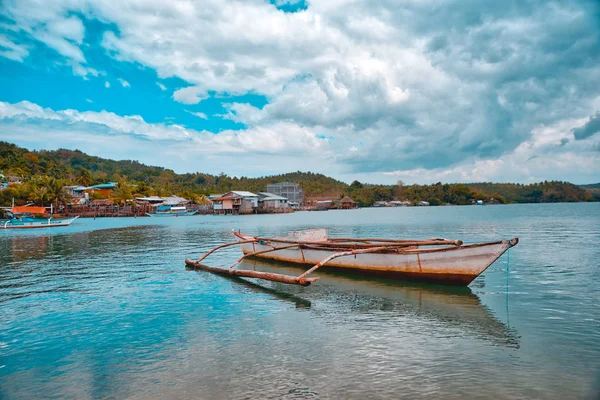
[0,0,600,181]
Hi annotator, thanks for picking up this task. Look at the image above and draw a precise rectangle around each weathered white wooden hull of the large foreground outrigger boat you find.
[235,233,518,286]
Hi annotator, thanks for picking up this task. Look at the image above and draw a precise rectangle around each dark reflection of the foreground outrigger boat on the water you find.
[213,259,519,348]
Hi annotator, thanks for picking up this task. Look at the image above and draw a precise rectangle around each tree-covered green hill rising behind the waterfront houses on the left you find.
[0,142,347,200]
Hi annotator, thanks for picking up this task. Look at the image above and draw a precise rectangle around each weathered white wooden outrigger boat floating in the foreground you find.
[185,229,519,286]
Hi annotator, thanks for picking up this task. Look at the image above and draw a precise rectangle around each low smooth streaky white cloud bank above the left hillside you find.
[0,102,331,176]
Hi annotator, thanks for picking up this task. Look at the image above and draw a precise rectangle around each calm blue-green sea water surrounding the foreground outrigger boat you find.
[0,203,600,399]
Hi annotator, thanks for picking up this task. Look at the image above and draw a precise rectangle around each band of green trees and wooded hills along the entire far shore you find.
[0,142,600,206]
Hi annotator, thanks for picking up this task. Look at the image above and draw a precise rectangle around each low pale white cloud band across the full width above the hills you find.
[0,101,600,184]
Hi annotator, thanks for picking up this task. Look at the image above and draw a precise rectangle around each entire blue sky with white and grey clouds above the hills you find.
[0,0,600,183]
